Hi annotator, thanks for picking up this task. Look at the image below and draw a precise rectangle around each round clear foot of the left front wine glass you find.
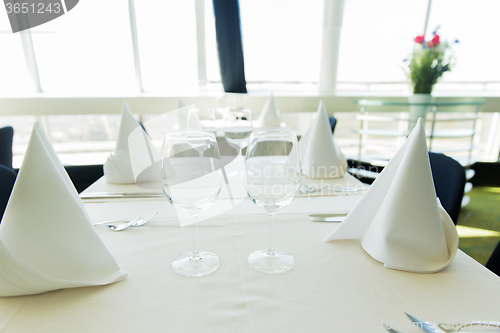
[172,252,219,277]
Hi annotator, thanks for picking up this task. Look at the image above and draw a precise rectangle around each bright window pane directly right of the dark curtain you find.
[240,0,323,84]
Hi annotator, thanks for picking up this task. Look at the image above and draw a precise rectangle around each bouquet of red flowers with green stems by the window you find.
[404,29,458,94]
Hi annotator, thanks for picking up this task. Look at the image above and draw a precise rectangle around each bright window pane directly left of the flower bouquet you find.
[337,0,426,90]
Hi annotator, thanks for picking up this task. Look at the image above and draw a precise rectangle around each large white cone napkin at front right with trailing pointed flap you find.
[326,119,458,273]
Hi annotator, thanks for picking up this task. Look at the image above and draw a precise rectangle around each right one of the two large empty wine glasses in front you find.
[244,130,302,274]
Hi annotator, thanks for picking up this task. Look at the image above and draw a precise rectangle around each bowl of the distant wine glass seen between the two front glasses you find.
[224,108,253,149]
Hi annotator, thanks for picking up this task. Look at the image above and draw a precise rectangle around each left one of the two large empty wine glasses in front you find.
[161,132,222,277]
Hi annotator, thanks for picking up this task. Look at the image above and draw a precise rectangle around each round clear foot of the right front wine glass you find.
[248,250,295,274]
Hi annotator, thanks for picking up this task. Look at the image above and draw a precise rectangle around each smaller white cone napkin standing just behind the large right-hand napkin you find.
[299,101,347,179]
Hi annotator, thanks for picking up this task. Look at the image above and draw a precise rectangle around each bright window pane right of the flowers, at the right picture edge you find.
[429,0,500,91]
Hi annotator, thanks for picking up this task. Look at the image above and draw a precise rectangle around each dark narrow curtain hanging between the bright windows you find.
[213,0,247,93]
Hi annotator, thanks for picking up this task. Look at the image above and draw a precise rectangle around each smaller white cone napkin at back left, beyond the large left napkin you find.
[104,102,161,184]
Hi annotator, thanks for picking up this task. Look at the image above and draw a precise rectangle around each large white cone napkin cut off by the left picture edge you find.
[0,123,127,296]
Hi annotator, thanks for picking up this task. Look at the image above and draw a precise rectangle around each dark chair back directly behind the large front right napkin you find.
[429,152,466,224]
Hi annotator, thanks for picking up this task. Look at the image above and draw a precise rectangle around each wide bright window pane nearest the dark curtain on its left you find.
[137,0,198,92]
